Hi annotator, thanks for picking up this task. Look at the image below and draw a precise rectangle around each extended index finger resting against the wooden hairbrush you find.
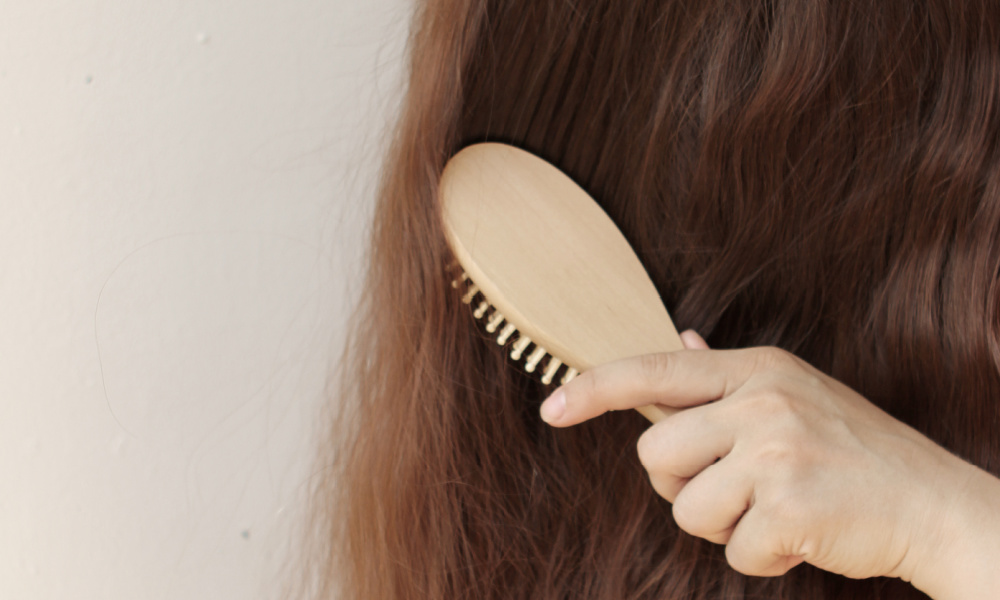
[541,338,756,427]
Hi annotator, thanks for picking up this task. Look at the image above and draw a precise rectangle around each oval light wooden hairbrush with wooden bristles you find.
[439,143,684,423]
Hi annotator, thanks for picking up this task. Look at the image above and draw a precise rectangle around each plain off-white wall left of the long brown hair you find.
[0,0,411,600]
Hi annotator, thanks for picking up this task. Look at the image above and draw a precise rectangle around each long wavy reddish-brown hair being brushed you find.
[302,0,1000,600]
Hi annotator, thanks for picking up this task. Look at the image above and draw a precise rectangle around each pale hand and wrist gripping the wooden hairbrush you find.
[541,331,1000,600]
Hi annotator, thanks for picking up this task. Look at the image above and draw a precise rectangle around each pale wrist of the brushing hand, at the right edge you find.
[906,456,1000,600]
